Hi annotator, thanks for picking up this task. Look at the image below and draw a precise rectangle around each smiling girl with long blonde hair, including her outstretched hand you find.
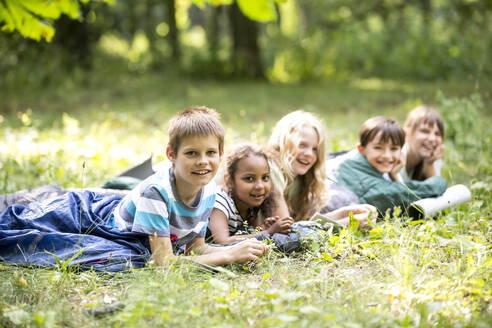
[267,110,376,226]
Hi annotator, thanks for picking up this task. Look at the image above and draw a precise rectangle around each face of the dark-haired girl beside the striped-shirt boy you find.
[232,155,272,209]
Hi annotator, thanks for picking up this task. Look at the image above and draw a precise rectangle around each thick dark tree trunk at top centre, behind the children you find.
[229,3,264,78]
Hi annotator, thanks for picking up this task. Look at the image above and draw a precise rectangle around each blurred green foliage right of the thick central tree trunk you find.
[264,0,492,82]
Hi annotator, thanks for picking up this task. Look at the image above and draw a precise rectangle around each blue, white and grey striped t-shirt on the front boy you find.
[114,168,216,246]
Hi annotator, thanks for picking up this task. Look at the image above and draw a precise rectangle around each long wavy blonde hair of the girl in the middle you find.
[267,110,326,221]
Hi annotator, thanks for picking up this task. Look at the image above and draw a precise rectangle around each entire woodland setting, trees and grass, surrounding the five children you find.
[0,0,492,327]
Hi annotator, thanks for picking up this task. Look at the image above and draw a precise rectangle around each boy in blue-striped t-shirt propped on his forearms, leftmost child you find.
[114,107,268,265]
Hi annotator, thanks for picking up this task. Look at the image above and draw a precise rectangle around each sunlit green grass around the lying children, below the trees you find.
[0,71,492,327]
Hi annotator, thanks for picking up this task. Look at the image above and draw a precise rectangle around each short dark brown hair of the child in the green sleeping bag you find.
[359,116,405,147]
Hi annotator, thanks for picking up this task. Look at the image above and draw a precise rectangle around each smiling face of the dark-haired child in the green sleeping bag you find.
[359,132,401,174]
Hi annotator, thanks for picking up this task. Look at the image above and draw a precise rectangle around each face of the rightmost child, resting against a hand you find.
[407,122,442,159]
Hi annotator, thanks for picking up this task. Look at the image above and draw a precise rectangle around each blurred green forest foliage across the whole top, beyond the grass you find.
[0,0,492,83]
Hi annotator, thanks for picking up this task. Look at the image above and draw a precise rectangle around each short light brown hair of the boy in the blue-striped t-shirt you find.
[168,106,225,153]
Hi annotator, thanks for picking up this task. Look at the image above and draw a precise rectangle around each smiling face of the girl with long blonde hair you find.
[292,127,319,176]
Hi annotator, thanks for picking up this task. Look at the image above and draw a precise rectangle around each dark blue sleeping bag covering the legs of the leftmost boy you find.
[0,191,150,272]
